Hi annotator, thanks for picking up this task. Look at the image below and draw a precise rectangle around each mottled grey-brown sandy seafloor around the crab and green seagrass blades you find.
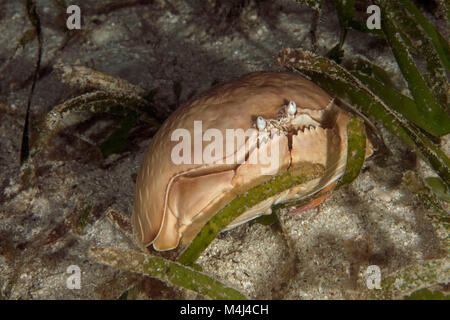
[0,0,448,299]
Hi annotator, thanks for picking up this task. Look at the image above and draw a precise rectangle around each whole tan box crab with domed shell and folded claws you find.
[132,72,370,251]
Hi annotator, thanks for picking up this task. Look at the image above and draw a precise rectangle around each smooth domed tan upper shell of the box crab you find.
[132,72,344,250]
